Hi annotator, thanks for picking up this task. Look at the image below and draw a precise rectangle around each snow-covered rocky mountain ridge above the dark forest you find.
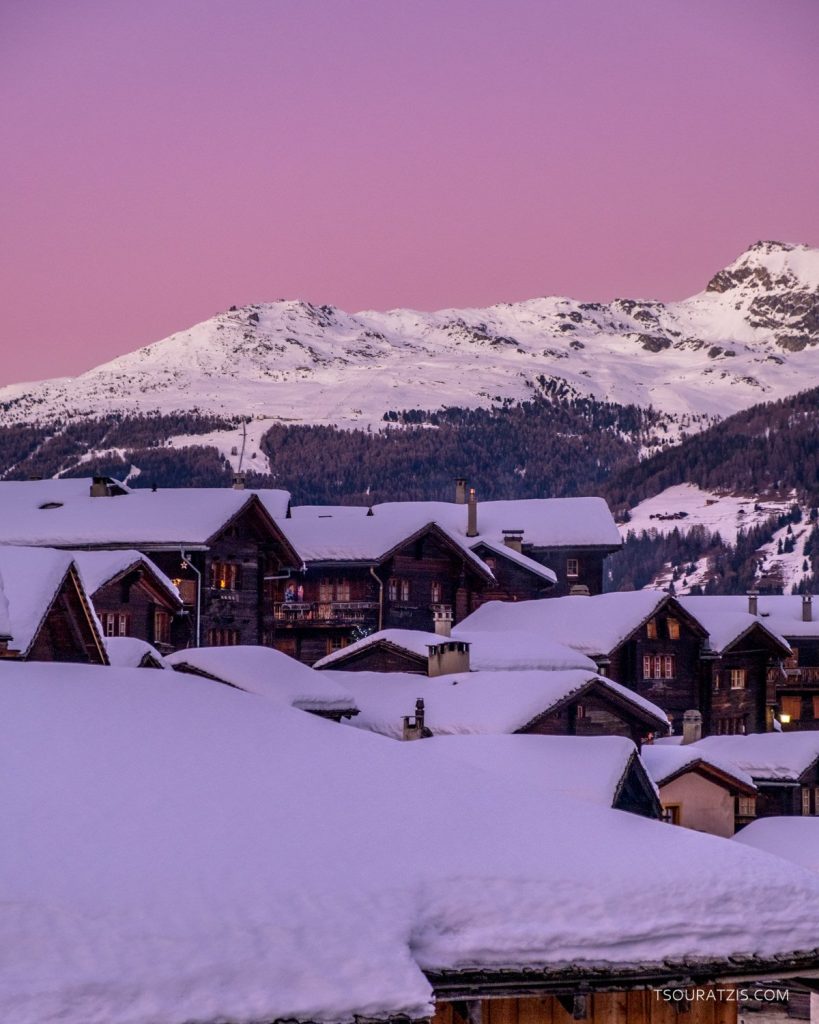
[0,242,819,431]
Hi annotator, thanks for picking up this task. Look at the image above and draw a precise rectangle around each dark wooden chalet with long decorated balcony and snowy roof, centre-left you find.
[268,509,493,665]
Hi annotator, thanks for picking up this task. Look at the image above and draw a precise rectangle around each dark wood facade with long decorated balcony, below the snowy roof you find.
[265,523,491,671]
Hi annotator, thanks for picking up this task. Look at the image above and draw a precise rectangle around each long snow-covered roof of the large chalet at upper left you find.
[0,478,290,548]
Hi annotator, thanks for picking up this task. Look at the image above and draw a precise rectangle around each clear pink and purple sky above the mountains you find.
[0,0,819,383]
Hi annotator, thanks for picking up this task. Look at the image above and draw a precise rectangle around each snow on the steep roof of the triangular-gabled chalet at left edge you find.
[0,545,79,654]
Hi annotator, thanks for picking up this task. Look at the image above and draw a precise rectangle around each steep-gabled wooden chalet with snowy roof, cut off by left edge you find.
[0,547,109,665]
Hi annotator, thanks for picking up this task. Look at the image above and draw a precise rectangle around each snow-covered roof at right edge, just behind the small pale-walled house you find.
[688,732,819,781]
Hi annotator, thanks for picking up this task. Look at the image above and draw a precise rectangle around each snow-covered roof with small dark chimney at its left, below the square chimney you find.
[321,669,667,738]
